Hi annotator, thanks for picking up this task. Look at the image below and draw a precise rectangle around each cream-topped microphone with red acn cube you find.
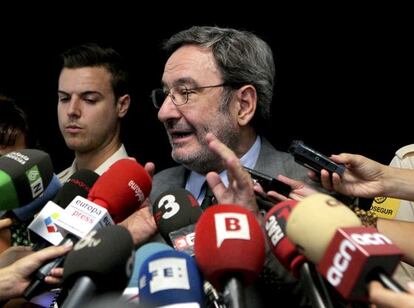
[286,194,404,300]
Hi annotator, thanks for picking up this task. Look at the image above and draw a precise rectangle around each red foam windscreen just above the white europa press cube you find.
[88,158,152,223]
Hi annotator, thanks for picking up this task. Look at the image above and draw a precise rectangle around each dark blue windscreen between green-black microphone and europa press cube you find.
[13,175,62,221]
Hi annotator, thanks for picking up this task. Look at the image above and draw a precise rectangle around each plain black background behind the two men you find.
[0,5,414,172]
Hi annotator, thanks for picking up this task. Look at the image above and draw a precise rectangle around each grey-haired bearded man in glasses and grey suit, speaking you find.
[147,27,309,307]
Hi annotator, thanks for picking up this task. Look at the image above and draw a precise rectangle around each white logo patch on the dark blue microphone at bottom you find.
[140,257,190,294]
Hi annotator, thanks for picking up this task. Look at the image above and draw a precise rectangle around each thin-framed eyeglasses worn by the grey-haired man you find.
[151,83,226,109]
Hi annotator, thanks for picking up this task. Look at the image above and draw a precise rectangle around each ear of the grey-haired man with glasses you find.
[237,85,257,126]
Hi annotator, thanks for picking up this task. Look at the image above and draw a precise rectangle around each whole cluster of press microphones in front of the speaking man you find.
[0,149,405,308]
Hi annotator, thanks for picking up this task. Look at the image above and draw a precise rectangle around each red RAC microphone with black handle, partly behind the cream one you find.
[265,200,333,307]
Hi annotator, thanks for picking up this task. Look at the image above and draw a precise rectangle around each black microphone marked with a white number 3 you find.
[152,188,203,255]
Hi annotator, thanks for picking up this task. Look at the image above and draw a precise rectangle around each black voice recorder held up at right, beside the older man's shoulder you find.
[288,140,345,175]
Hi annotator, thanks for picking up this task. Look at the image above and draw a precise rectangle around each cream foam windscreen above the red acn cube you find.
[286,193,361,263]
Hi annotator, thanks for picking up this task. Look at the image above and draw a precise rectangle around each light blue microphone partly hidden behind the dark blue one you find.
[122,242,172,304]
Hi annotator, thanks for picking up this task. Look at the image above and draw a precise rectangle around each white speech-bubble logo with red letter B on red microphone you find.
[214,213,250,248]
